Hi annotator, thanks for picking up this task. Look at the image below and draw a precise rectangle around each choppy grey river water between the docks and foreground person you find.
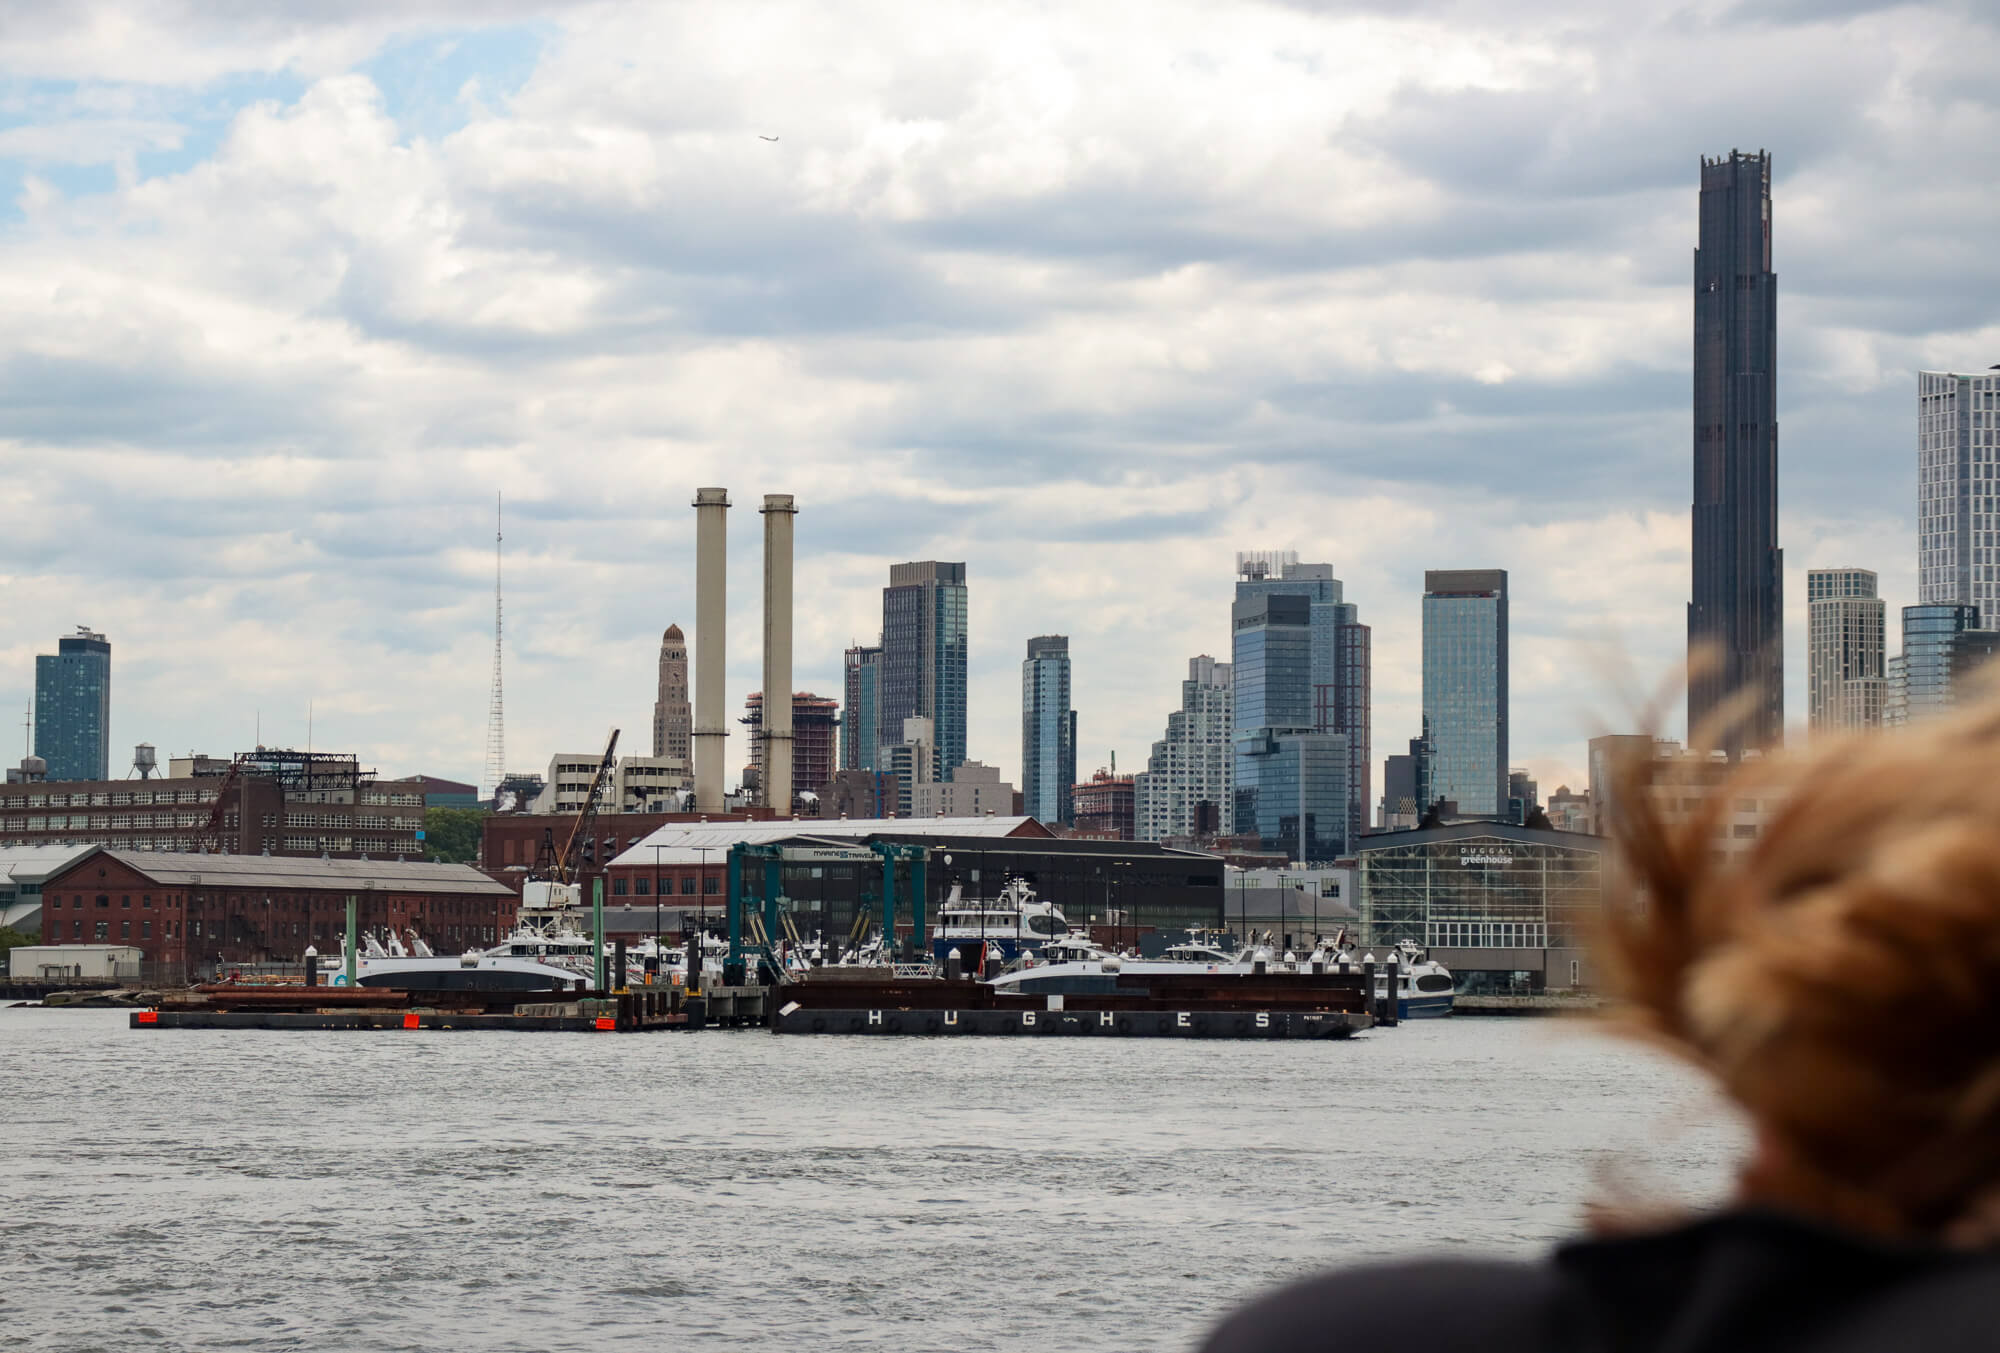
[0,1009,1738,1353]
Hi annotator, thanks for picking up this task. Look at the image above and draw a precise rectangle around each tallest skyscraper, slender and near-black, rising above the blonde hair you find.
[1688,150,1784,757]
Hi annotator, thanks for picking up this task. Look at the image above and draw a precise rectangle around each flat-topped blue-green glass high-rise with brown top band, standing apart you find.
[1424,568,1508,819]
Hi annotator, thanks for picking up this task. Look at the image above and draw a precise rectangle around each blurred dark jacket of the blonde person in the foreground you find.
[1204,1213,2000,1353]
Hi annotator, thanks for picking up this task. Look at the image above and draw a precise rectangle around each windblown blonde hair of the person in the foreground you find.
[1602,697,2000,1245]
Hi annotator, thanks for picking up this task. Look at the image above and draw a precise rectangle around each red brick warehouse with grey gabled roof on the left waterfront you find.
[42,847,518,981]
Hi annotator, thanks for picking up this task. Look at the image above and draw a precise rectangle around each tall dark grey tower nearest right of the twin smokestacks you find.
[876,558,966,779]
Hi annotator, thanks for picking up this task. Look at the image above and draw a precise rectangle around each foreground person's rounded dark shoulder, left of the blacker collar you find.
[1202,1259,1560,1353]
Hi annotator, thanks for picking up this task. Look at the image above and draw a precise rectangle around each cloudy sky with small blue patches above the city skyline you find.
[0,0,2000,793]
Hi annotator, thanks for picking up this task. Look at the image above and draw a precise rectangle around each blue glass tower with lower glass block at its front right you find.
[1230,590,1350,863]
